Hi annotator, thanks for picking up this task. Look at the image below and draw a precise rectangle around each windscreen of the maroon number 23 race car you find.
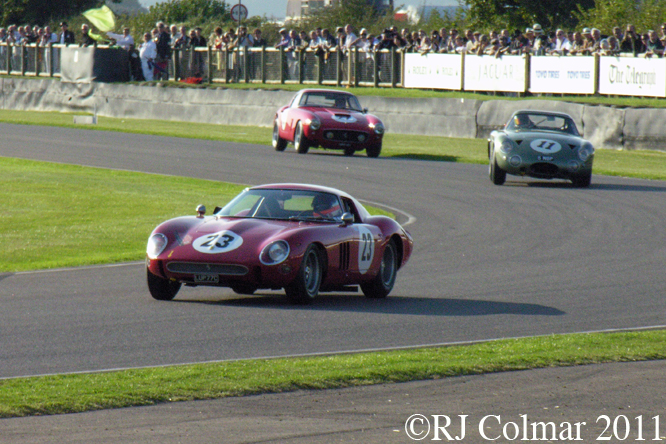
[215,189,342,222]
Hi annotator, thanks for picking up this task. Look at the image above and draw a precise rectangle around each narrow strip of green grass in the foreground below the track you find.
[0,330,666,417]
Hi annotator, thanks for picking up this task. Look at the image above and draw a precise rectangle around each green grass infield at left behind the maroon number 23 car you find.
[0,157,393,272]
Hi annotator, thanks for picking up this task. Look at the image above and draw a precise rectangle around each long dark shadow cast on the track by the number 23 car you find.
[173,294,566,316]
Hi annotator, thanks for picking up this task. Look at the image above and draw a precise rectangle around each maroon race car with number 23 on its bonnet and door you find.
[146,184,413,304]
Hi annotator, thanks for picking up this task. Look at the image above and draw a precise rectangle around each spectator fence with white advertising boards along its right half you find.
[0,43,666,97]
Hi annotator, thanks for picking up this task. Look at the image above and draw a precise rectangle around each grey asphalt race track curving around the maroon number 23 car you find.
[0,120,666,378]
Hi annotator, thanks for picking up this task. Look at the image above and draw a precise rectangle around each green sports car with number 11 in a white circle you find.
[488,110,594,187]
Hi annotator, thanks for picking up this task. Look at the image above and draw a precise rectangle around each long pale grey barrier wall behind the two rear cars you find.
[0,78,666,150]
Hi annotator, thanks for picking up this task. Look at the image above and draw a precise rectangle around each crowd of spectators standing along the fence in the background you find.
[0,22,666,80]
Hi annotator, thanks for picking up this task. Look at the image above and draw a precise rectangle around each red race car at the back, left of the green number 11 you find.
[273,89,384,157]
